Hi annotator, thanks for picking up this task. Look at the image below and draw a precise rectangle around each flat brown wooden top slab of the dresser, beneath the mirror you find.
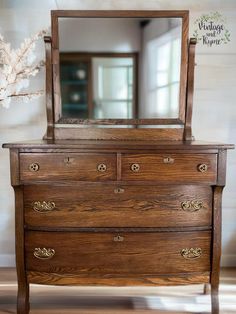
[3,138,235,154]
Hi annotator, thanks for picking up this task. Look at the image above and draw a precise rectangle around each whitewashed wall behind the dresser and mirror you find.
[0,0,236,266]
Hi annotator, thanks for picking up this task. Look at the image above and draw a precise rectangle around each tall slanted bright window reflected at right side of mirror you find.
[148,28,181,118]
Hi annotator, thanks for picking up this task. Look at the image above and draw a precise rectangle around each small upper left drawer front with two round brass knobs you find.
[20,153,116,181]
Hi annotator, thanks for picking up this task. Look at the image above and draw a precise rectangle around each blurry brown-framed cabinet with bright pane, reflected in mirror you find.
[60,52,138,119]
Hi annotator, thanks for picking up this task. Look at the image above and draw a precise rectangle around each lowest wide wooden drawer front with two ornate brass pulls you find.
[25,231,210,275]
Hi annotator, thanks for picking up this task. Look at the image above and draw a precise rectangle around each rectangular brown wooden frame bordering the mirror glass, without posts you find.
[51,10,189,127]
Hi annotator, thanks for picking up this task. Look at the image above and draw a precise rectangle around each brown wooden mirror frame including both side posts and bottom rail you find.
[45,10,195,140]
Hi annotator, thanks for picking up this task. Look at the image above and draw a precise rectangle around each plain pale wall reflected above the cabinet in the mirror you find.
[59,18,140,52]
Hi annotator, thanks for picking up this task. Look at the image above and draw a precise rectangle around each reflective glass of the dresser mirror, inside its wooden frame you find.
[59,18,182,119]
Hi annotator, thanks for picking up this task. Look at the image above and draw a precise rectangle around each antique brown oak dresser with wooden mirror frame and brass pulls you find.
[4,11,233,314]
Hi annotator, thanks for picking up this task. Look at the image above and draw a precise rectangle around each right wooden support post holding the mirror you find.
[184,38,197,141]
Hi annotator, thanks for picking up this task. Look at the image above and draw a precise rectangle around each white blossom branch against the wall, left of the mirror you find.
[0,31,46,108]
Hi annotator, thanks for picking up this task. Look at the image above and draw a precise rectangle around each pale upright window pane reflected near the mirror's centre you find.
[92,58,134,119]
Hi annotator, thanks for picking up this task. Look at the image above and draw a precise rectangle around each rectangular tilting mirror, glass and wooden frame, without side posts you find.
[52,11,188,128]
